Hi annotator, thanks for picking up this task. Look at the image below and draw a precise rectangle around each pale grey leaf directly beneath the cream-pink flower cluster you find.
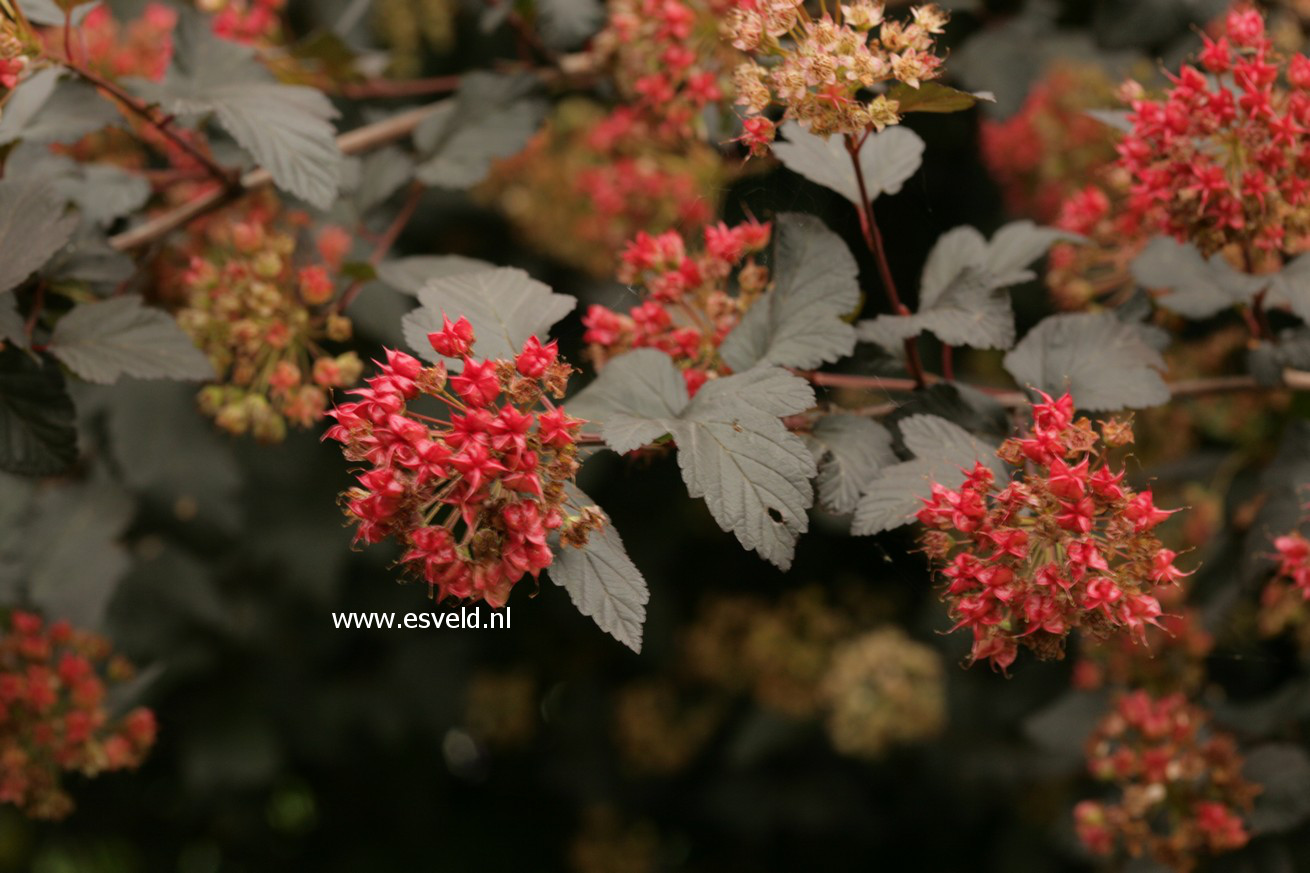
[773,122,924,207]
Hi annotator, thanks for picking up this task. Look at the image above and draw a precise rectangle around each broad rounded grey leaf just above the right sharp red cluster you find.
[1005,312,1170,412]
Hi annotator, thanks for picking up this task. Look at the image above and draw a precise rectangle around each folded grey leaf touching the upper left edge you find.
[0,67,123,146]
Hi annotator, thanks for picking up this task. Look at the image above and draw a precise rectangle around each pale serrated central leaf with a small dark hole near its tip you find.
[669,367,816,570]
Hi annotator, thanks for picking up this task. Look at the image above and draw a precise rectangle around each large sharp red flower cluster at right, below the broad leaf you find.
[918,395,1186,670]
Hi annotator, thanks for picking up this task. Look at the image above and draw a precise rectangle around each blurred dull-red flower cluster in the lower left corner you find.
[0,611,155,818]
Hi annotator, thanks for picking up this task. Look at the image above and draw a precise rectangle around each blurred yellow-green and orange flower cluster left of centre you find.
[177,194,363,442]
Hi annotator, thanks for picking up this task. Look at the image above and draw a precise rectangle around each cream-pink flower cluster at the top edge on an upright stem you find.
[724,0,947,155]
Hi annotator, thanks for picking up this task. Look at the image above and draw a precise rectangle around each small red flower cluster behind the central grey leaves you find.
[583,220,773,395]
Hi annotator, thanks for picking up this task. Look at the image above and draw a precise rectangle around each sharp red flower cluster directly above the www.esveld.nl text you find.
[324,319,603,607]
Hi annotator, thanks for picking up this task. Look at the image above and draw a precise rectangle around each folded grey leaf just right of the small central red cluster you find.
[719,214,859,372]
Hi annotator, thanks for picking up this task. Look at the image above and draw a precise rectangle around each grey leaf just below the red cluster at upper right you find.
[1132,236,1267,319]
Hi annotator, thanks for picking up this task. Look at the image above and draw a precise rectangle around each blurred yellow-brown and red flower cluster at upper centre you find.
[479,100,730,275]
